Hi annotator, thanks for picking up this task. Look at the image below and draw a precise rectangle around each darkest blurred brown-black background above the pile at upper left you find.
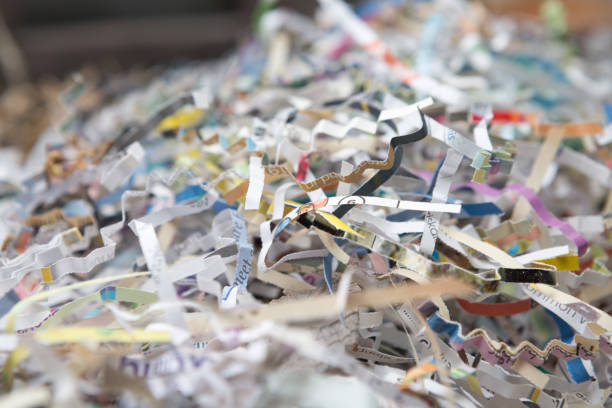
[0,0,326,83]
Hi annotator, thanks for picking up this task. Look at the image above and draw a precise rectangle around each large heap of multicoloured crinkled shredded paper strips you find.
[0,0,612,408]
